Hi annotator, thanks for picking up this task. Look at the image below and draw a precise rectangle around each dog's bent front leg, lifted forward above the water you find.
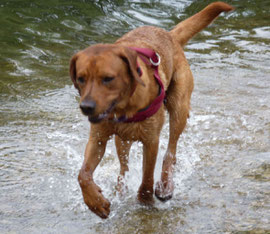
[78,136,110,218]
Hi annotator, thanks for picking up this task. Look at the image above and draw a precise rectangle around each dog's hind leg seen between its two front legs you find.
[115,136,133,193]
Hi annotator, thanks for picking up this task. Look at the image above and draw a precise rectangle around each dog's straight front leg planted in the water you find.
[138,139,159,205]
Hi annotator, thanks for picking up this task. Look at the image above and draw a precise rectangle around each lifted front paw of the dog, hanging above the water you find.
[82,182,111,219]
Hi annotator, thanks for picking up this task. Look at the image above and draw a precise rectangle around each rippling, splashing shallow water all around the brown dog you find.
[0,0,270,233]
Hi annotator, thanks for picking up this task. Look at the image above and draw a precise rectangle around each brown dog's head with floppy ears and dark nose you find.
[70,45,144,123]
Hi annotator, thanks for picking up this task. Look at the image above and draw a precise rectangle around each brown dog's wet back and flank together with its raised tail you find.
[115,2,233,89]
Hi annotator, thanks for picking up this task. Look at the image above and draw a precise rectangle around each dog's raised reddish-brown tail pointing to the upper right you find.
[170,2,234,47]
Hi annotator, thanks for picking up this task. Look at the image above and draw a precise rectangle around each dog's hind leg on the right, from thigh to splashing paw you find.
[155,53,193,201]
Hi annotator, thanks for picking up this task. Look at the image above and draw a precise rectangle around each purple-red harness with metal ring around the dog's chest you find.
[114,47,165,123]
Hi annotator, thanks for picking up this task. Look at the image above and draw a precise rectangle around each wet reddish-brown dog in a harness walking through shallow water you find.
[70,2,233,218]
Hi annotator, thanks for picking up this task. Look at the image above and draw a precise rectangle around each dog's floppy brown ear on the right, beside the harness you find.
[120,48,145,86]
